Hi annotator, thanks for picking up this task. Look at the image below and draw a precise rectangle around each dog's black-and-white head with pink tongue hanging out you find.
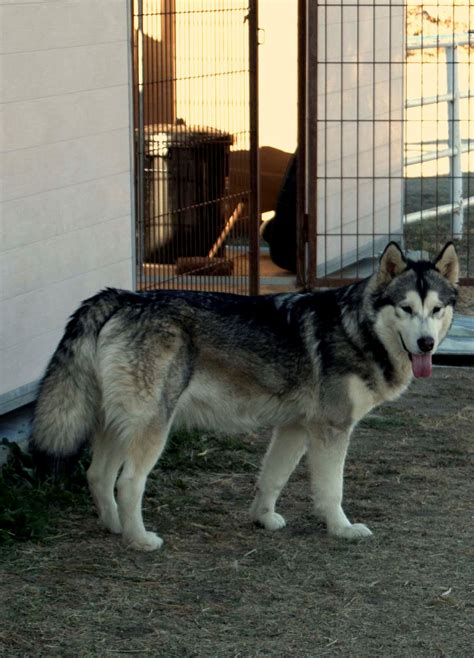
[372,242,459,377]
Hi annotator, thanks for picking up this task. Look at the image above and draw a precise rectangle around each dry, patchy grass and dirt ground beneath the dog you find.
[0,368,474,658]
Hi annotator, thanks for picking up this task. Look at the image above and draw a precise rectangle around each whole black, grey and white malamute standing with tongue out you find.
[32,242,459,551]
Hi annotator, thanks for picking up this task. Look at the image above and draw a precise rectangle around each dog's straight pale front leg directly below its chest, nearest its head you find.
[308,425,372,539]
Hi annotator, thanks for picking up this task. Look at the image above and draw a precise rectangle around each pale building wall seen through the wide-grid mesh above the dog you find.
[309,0,405,276]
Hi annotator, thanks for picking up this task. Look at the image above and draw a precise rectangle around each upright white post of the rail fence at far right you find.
[446,43,464,239]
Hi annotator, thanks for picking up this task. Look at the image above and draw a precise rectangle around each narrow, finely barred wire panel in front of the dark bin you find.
[133,0,258,293]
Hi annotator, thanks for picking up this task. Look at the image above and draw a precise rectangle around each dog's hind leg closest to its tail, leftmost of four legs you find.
[87,432,126,534]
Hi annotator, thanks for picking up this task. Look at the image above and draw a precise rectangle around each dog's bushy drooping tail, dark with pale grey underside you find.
[30,289,120,467]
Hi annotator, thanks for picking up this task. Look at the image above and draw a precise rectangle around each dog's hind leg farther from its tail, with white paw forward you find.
[117,419,171,551]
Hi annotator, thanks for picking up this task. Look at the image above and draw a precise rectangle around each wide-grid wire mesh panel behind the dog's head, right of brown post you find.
[308,0,474,284]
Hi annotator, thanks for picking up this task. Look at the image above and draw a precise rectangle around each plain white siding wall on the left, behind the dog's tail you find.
[0,0,132,412]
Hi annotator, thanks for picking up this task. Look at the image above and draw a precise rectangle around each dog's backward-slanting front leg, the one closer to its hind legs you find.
[250,426,308,530]
